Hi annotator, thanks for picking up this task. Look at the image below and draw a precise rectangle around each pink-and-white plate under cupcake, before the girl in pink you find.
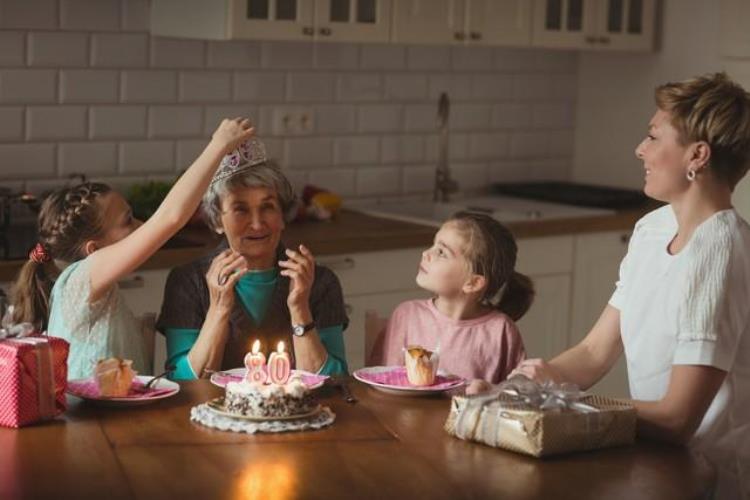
[352,366,466,396]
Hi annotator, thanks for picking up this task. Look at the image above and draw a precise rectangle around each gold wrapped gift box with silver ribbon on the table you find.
[445,394,636,457]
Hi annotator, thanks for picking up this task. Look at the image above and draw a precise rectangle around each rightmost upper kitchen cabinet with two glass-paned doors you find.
[532,0,657,51]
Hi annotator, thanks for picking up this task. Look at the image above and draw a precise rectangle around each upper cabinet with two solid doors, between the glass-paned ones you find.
[391,0,531,45]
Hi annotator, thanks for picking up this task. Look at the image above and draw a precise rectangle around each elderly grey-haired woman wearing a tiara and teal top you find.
[157,139,347,379]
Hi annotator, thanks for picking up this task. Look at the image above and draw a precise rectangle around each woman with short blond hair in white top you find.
[508,73,750,498]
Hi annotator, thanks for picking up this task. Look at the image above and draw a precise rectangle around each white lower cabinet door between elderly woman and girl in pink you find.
[344,289,429,372]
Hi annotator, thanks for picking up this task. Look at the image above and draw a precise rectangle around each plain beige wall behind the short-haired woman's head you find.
[572,0,750,217]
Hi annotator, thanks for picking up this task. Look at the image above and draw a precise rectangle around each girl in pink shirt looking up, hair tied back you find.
[368,212,534,384]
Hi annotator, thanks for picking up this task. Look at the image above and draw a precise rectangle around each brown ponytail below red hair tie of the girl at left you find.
[11,259,54,331]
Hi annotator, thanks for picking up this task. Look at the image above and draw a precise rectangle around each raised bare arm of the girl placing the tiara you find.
[90,118,254,301]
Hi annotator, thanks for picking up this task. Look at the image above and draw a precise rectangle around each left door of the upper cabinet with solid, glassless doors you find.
[391,0,466,43]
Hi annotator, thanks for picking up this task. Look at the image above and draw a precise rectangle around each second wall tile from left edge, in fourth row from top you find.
[26,106,88,141]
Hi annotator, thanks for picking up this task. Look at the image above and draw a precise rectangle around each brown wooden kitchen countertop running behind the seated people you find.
[0,205,654,282]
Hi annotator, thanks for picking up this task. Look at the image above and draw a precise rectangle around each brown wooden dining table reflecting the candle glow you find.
[0,380,712,500]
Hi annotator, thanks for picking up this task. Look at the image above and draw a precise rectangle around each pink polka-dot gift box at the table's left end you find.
[0,335,70,427]
